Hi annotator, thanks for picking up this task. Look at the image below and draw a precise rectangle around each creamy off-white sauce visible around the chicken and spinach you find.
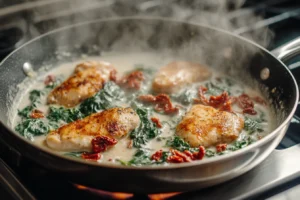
[12,52,272,163]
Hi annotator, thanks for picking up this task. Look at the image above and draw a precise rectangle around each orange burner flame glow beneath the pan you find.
[73,184,180,200]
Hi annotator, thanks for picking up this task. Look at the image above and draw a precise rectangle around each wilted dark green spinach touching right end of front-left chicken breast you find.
[130,108,161,148]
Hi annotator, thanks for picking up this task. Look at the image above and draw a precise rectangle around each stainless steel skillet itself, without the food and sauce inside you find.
[0,17,299,193]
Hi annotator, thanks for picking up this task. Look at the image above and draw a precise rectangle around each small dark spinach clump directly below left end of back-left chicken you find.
[47,106,83,123]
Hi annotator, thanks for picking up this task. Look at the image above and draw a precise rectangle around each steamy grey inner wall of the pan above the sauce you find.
[0,19,296,161]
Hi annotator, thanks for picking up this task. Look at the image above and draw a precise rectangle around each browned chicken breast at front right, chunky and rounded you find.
[176,104,244,147]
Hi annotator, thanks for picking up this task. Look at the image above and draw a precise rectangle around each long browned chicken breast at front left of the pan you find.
[46,108,140,151]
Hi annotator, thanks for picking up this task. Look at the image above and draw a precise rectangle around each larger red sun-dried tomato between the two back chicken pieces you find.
[119,71,145,90]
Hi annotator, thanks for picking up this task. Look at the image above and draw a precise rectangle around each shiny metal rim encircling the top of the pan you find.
[0,16,299,170]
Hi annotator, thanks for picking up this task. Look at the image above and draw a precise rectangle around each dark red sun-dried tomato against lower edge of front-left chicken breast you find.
[92,136,118,153]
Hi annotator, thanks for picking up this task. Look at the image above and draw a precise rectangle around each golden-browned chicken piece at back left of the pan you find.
[47,62,116,107]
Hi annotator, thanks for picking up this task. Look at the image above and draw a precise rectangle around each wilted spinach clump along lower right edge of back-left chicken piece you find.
[79,81,124,116]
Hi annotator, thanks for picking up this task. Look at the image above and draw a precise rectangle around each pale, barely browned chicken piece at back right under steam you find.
[152,61,212,93]
